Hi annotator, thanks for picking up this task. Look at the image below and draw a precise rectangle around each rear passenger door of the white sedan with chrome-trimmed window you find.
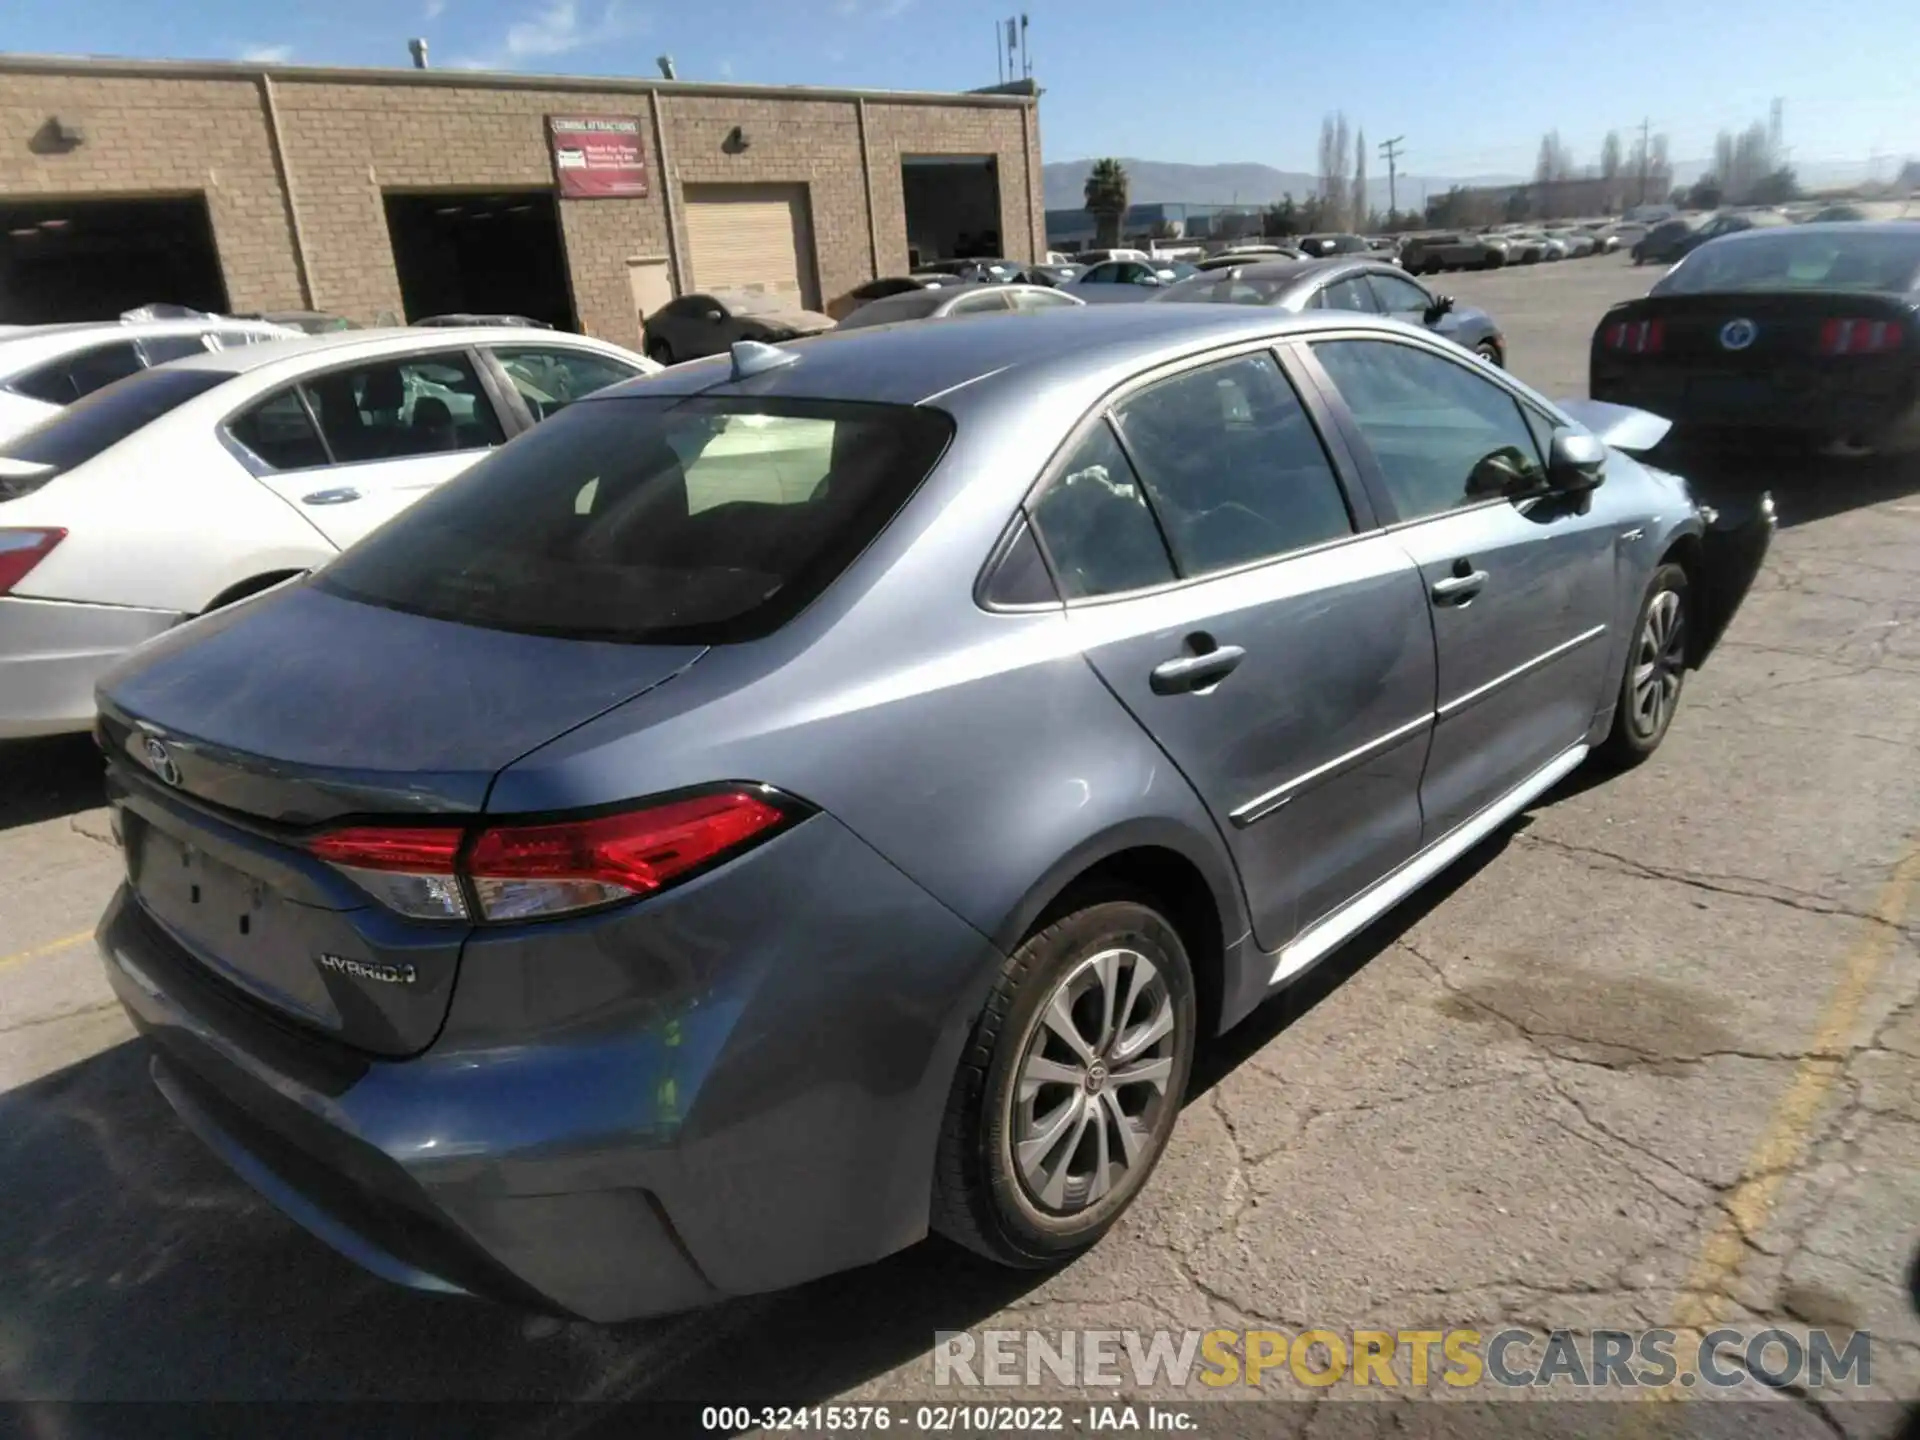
[227,349,505,547]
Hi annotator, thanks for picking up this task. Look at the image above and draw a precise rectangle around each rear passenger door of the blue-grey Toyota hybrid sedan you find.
[1031,349,1434,963]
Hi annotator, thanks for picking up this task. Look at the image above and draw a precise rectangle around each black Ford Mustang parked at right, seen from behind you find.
[1590,221,1920,449]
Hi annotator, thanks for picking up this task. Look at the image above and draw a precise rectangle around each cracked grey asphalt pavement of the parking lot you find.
[0,259,1920,1434]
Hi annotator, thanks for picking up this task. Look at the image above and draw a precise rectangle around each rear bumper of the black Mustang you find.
[1588,367,1920,444]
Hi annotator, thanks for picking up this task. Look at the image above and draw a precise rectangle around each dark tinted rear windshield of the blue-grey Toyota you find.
[319,396,952,645]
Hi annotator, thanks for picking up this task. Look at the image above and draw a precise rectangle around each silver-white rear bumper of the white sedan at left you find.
[0,595,184,739]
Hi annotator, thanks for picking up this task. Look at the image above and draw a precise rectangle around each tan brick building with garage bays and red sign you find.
[0,56,1044,346]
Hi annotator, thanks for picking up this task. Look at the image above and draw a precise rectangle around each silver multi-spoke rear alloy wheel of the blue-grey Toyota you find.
[1012,948,1179,1215]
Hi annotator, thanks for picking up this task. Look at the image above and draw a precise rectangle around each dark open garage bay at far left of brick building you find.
[0,196,227,324]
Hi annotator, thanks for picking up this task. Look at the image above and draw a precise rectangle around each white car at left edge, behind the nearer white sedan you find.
[0,315,300,440]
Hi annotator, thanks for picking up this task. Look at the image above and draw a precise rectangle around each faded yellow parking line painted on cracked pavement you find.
[1645,851,1920,1400]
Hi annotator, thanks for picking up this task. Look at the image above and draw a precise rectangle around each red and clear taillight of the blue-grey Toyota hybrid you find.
[307,787,804,922]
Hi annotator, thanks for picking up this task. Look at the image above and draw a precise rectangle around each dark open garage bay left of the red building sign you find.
[386,190,578,330]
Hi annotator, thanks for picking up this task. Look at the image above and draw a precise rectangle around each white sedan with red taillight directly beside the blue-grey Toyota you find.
[0,326,659,737]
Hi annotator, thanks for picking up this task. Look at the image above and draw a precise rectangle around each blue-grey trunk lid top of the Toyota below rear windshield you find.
[98,580,705,826]
